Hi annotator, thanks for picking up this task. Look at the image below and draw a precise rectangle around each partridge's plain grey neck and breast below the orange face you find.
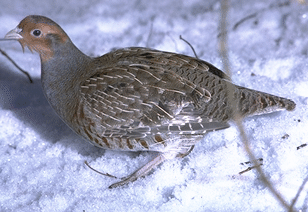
[41,42,92,122]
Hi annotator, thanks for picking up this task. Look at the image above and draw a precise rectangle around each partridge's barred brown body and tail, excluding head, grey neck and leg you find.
[74,48,295,159]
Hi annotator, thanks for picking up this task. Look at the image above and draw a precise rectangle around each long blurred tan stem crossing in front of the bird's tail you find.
[219,0,292,211]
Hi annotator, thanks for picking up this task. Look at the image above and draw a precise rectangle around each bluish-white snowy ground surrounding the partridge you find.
[0,0,308,212]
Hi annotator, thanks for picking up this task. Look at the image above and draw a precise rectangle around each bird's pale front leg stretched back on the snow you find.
[109,153,166,188]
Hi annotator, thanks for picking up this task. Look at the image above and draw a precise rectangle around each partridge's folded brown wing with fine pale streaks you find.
[80,48,228,141]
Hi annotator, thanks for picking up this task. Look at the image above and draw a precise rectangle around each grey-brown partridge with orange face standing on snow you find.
[4,15,296,188]
